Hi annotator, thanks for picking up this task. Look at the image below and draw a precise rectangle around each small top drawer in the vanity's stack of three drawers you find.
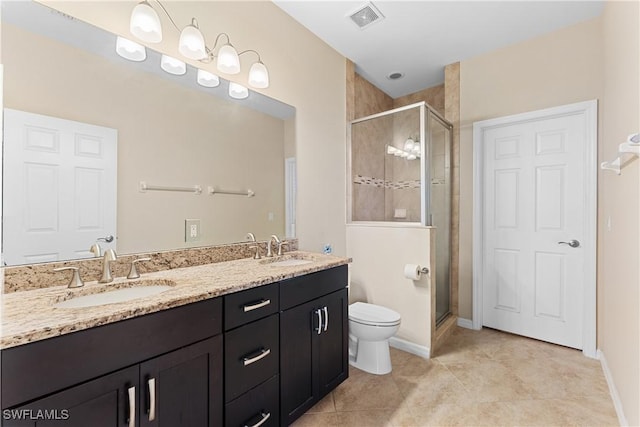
[224,283,279,331]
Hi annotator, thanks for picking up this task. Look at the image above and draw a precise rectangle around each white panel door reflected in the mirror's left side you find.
[3,109,117,265]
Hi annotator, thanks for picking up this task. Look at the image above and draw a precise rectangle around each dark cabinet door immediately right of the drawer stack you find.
[280,300,320,425]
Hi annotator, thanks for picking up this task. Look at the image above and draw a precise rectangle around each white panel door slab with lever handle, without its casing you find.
[482,114,586,348]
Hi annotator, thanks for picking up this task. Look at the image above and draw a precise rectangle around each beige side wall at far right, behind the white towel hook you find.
[598,1,640,426]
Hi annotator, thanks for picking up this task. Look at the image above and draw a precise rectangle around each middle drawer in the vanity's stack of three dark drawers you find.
[224,313,280,402]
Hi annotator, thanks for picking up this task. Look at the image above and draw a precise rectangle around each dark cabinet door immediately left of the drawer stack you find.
[140,335,223,427]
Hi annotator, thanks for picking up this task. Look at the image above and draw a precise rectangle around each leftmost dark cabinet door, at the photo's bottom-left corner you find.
[3,366,140,427]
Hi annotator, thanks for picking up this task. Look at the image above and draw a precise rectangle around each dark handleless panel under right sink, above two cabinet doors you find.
[280,265,348,310]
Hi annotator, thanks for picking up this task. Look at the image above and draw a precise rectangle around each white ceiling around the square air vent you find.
[274,0,604,98]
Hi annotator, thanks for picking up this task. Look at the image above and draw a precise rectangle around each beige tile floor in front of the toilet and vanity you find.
[293,327,618,427]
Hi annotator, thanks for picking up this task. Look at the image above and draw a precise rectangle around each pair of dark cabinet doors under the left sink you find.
[3,336,222,427]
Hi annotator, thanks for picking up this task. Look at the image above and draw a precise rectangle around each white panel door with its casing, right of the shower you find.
[473,101,597,357]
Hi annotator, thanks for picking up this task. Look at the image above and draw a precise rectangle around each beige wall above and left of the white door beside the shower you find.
[459,18,603,319]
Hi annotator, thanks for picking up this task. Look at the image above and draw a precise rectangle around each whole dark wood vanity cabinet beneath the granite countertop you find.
[0,266,349,427]
